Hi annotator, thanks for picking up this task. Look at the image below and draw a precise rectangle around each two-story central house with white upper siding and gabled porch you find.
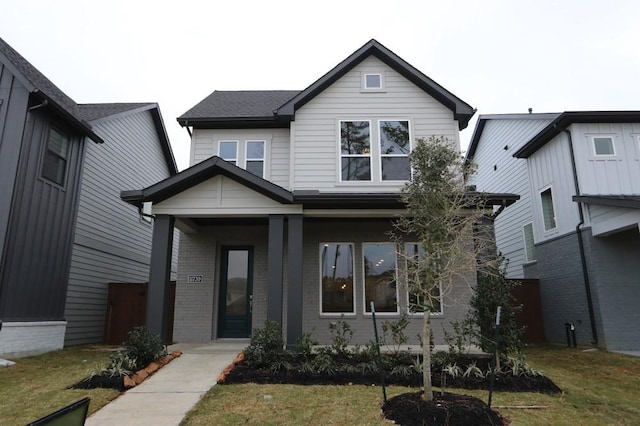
[122,40,517,346]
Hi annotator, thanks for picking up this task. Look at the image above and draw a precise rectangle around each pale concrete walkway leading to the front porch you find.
[85,341,248,426]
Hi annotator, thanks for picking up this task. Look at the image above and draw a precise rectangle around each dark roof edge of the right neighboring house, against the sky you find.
[513,111,640,158]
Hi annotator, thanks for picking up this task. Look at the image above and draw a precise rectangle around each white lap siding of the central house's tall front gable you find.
[292,56,460,192]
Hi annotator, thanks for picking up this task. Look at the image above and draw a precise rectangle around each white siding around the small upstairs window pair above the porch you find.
[190,129,290,189]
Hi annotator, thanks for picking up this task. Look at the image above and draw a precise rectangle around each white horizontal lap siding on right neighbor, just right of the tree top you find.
[470,116,551,278]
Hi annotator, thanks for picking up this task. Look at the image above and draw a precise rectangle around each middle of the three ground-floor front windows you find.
[362,243,399,313]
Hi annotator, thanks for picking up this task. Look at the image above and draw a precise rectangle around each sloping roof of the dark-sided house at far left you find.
[0,38,104,143]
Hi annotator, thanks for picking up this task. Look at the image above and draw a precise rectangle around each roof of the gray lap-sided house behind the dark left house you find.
[78,102,178,176]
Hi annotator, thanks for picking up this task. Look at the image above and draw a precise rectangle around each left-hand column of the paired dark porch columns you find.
[267,215,284,325]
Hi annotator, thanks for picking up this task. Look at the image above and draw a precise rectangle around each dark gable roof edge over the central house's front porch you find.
[120,156,293,208]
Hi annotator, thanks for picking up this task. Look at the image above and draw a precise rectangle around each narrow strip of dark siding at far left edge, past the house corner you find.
[0,63,29,270]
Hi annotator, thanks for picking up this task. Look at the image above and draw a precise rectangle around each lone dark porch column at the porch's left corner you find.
[147,215,175,343]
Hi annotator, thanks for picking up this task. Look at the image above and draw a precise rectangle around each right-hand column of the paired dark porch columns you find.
[287,215,304,349]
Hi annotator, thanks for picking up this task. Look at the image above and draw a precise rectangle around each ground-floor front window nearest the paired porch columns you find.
[320,243,355,314]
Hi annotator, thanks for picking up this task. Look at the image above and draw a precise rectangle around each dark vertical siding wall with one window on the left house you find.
[0,108,84,320]
